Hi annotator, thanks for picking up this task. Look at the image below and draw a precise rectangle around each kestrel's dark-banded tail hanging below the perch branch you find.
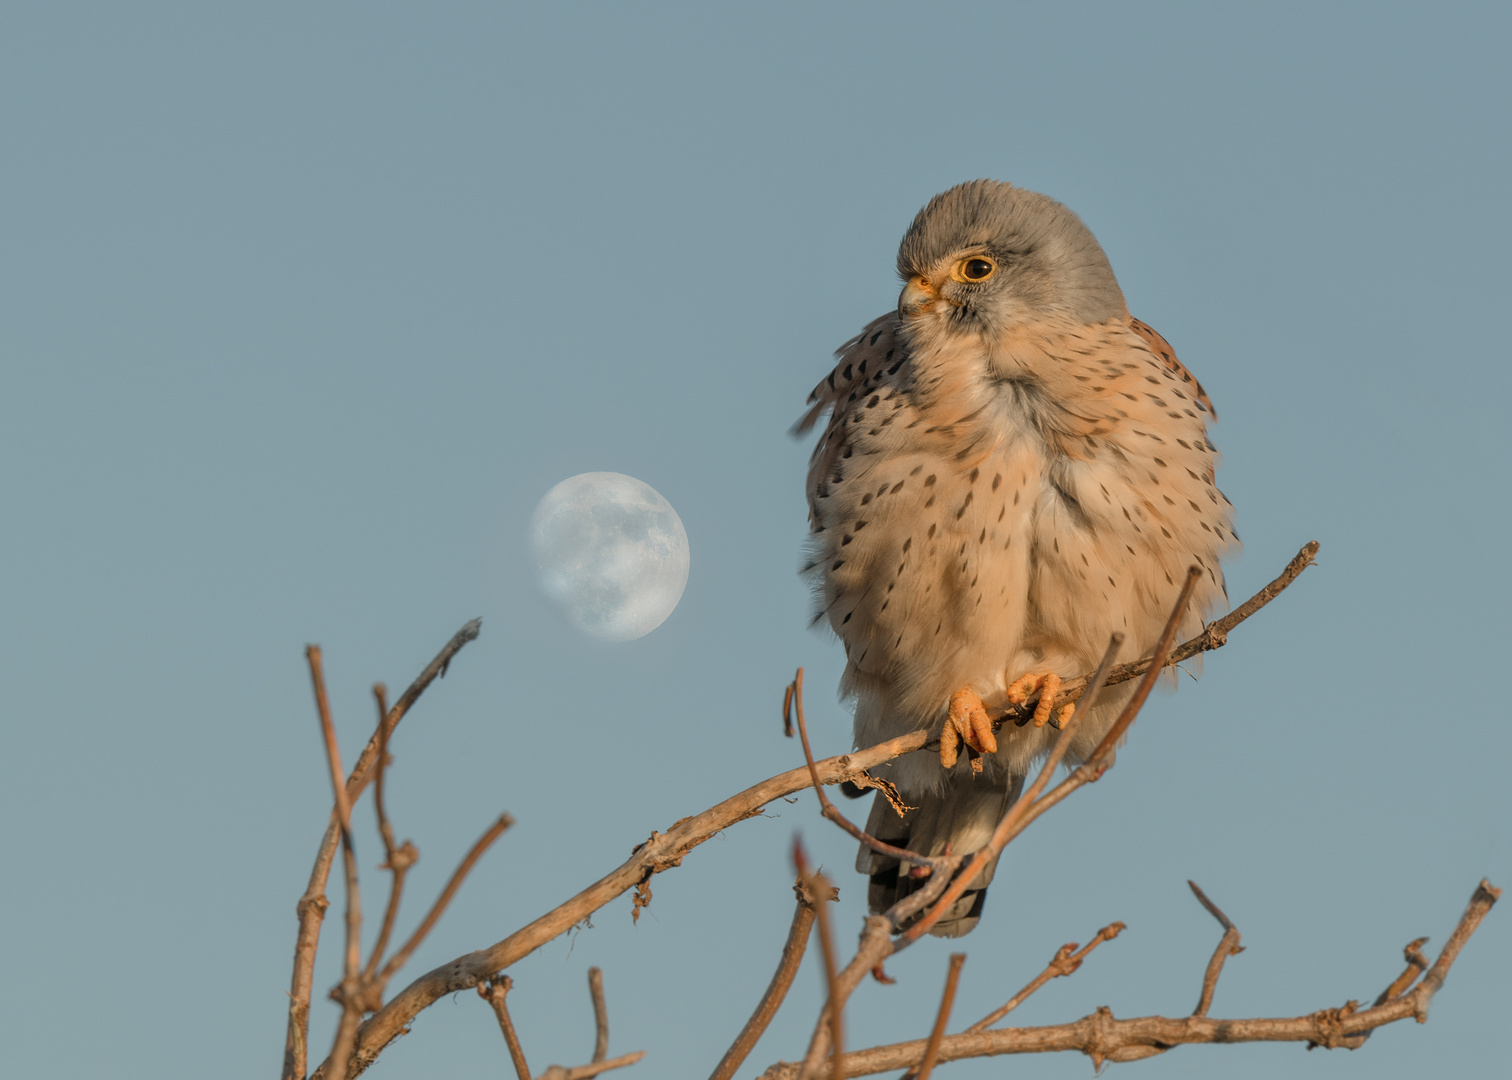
[856,776,1024,938]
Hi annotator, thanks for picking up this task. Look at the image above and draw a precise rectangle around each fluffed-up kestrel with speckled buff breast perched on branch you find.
[794,180,1240,936]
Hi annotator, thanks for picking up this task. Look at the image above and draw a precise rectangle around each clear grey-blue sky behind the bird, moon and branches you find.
[0,3,1512,1080]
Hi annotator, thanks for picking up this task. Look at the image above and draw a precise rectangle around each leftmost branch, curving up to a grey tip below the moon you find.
[283,619,482,1080]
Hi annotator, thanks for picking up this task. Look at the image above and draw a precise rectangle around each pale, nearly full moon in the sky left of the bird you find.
[531,472,688,641]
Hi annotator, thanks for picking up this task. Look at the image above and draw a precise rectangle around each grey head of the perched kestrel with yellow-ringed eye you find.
[898,180,1128,334]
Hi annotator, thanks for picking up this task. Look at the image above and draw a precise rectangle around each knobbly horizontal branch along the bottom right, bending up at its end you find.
[761,882,1501,1080]
